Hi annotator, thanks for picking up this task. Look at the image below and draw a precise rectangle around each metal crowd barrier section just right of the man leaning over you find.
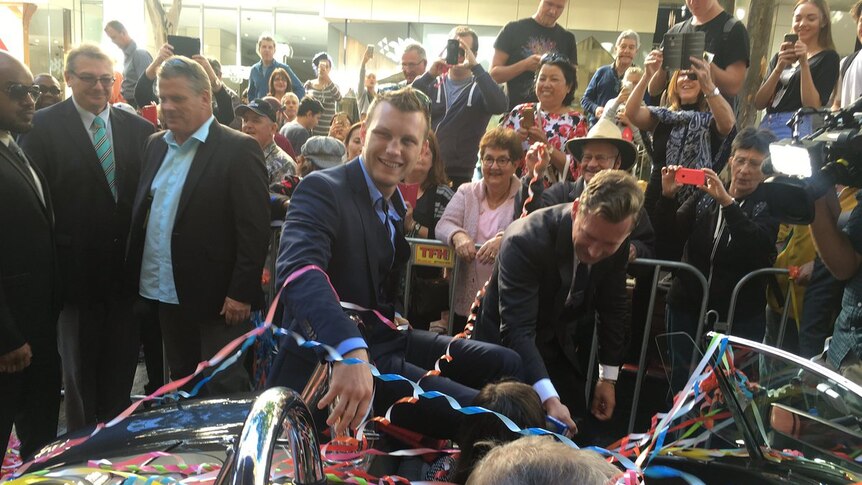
[624,258,709,434]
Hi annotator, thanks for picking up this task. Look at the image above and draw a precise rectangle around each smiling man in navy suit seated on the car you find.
[270,87,521,438]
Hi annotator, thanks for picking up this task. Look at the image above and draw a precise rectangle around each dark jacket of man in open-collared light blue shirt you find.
[127,120,271,317]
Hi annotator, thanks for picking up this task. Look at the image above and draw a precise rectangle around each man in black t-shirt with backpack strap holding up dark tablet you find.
[649,0,751,106]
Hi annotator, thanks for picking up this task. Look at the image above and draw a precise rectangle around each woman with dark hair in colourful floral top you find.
[501,54,587,183]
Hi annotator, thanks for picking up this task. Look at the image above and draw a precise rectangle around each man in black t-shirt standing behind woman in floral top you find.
[491,0,578,109]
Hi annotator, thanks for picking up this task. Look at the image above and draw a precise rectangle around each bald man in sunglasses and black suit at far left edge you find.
[0,52,60,457]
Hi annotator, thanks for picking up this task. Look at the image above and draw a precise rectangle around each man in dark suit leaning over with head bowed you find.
[474,170,643,438]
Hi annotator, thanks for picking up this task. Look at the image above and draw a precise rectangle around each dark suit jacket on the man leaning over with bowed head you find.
[474,203,629,384]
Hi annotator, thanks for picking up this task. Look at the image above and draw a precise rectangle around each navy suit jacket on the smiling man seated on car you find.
[277,158,410,357]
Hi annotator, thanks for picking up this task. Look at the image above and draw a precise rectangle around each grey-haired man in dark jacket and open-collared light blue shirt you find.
[128,56,270,394]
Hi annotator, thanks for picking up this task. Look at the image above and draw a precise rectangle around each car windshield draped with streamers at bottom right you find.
[653,334,862,481]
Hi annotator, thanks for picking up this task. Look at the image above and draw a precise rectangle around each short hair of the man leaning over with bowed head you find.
[578,170,644,224]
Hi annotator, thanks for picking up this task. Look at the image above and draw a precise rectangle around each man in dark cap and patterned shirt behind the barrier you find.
[236,99,296,184]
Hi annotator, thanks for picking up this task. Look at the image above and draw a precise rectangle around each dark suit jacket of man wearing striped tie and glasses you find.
[19,98,155,303]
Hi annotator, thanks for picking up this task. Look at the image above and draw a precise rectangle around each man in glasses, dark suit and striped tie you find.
[20,45,153,431]
